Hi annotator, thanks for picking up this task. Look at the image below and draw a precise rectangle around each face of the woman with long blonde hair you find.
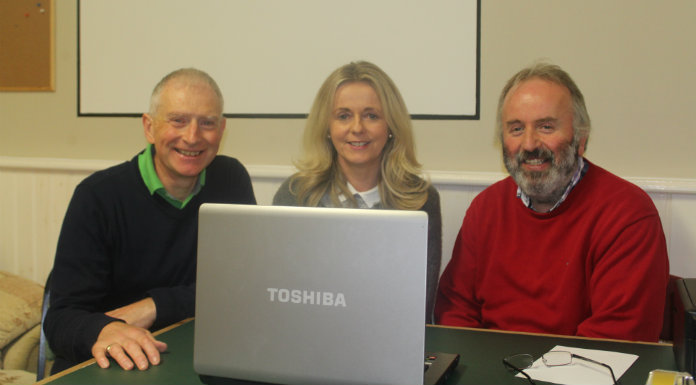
[329,82,389,182]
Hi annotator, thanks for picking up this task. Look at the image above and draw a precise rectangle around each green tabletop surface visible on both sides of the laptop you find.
[40,322,676,385]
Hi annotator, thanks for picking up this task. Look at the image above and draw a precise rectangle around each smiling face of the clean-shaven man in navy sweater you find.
[143,78,225,191]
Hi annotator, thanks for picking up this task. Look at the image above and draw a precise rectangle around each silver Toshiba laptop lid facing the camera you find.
[194,204,428,385]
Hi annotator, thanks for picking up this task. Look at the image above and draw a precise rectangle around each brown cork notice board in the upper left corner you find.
[0,0,55,91]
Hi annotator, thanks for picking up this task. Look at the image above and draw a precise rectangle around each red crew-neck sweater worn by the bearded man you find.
[435,160,669,341]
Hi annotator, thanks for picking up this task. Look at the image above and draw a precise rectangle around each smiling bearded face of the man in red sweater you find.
[502,78,586,207]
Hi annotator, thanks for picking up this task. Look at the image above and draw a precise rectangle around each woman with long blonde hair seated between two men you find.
[273,62,442,323]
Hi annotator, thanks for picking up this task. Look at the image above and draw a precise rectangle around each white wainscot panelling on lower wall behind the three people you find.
[0,157,696,283]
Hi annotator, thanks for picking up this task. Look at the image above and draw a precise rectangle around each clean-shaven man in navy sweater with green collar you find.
[44,68,256,373]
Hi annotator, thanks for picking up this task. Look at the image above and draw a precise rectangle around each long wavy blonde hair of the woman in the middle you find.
[290,61,430,210]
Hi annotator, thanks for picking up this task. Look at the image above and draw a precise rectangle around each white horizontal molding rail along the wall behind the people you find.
[5,156,696,194]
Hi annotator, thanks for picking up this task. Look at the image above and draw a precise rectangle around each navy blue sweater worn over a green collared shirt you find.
[44,156,256,373]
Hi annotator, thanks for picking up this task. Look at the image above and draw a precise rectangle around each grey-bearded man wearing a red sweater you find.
[435,64,669,341]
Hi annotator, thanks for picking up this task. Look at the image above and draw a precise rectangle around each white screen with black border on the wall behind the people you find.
[78,0,480,119]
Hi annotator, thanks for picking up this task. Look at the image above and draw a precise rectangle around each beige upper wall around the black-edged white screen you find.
[0,0,696,178]
